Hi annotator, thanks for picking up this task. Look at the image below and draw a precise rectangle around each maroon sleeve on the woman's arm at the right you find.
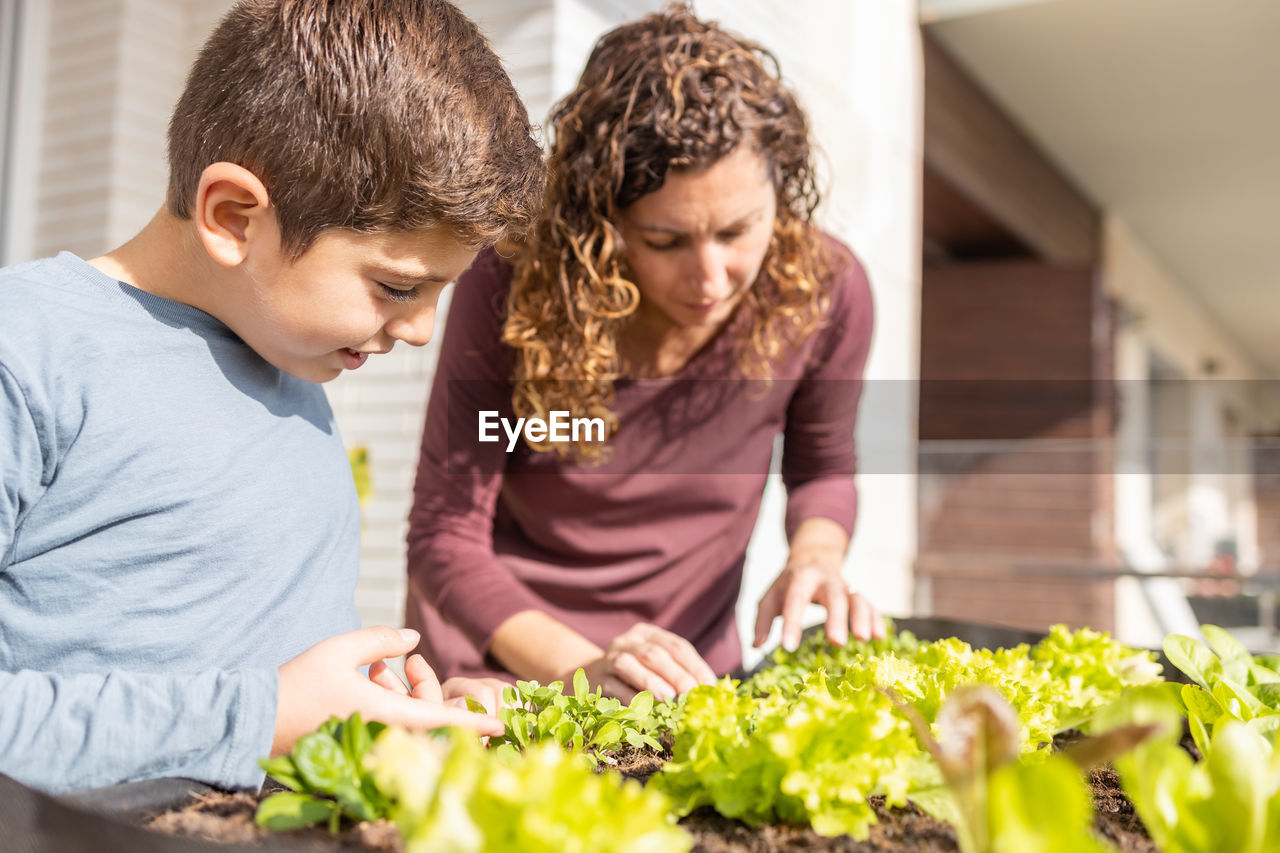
[782,235,873,538]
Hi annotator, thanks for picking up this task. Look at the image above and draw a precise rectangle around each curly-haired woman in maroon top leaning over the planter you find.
[406,6,883,699]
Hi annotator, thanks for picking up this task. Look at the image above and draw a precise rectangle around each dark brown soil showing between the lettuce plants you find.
[140,749,1158,853]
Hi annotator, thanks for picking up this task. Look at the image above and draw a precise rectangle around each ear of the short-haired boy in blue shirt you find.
[195,163,279,266]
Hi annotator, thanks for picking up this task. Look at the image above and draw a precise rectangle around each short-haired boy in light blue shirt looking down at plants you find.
[0,0,543,792]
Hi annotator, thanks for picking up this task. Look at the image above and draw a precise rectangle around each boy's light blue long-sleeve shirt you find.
[0,252,360,792]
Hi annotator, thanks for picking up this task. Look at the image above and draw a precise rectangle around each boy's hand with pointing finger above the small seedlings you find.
[271,626,503,756]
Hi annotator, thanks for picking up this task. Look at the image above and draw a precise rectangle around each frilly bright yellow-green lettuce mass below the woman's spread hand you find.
[655,626,1160,838]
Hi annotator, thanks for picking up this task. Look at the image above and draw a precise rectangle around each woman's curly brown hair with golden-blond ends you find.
[503,4,831,462]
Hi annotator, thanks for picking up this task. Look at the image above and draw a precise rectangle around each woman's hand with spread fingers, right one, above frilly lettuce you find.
[755,519,884,652]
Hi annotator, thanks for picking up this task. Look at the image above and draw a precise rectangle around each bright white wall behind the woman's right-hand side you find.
[696,0,923,655]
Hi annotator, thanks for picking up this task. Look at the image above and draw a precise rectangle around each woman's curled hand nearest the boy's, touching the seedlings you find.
[573,622,716,702]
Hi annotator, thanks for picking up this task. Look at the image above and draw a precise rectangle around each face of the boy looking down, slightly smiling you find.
[230,227,476,382]
